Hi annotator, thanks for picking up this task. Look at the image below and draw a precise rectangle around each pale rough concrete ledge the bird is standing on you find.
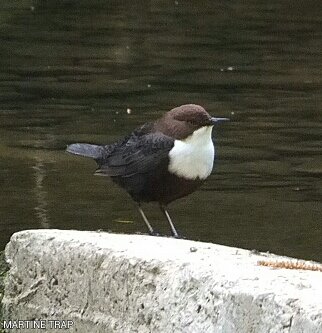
[3,230,322,333]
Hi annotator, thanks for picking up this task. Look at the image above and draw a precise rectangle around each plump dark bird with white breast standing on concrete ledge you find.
[66,104,229,238]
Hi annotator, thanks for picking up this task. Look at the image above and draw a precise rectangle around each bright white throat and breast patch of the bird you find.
[168,126,215,179]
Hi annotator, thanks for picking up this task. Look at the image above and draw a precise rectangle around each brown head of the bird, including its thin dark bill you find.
[154,104,228,140]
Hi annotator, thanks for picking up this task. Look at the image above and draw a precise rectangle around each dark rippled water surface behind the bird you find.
[0,0,322,261]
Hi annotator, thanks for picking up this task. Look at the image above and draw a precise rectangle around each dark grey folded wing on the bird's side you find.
[96,133,174,177]
